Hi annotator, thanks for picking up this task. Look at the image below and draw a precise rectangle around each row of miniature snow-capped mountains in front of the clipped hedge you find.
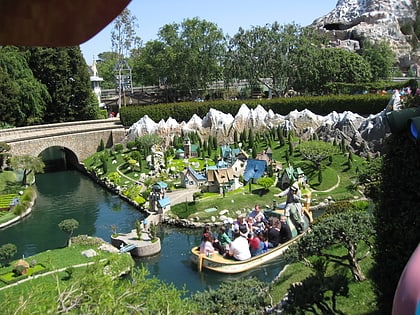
[127,99,389,156]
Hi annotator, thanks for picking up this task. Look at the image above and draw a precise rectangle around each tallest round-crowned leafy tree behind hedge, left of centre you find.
[142,18,225,97]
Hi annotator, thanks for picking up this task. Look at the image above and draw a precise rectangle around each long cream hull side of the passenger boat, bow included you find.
[191,234,304,274]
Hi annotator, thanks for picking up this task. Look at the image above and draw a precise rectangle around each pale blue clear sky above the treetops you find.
[80,0,337,64]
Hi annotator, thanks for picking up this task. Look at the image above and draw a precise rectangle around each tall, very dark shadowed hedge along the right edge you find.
[373,134,420,314]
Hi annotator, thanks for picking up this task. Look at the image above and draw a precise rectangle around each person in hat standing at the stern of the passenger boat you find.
[278,182,305,234]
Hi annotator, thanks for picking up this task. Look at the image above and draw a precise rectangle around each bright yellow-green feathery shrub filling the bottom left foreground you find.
[2,264,199,315]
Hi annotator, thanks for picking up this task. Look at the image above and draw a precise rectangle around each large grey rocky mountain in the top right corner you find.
[312,0,420,70]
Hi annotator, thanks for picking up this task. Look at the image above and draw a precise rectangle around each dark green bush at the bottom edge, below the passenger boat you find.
[191,278,270,315]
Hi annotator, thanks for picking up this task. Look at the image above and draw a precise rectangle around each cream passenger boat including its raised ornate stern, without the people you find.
[191,193,312,274]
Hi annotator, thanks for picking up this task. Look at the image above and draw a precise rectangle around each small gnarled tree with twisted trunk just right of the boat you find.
[290,211,375,281]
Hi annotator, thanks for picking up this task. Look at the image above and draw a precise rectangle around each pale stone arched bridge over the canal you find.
[0,118,125,165]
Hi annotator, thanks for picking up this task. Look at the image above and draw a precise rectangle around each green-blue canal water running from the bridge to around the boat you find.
[0,171,284,293]
